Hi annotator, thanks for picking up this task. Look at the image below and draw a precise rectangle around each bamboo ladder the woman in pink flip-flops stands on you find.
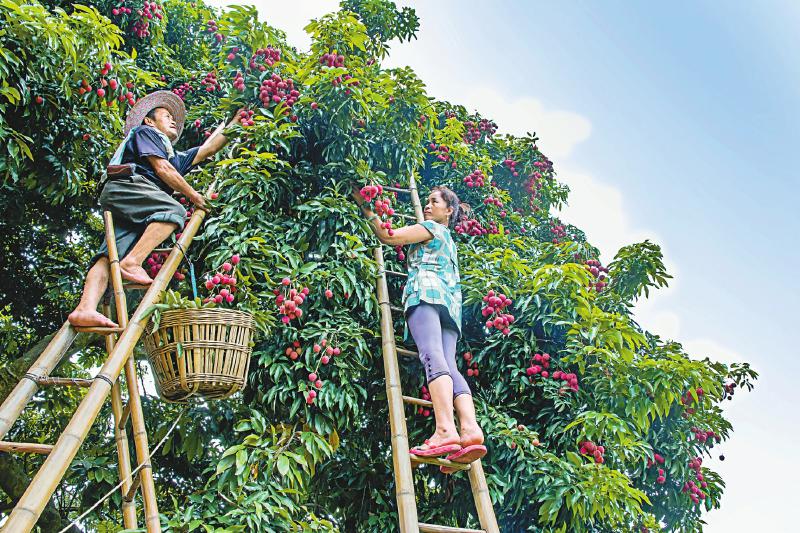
[375,176,500,533]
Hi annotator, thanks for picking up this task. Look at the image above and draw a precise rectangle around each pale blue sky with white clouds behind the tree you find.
[209,0,800,532]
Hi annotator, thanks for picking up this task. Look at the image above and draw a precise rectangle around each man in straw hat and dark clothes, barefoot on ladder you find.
[68,91,241,327]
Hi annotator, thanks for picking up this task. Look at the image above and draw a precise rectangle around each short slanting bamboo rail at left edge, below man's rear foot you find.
[0,322,77,439]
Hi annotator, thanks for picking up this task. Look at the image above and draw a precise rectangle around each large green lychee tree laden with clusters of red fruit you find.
[0,0,756,531]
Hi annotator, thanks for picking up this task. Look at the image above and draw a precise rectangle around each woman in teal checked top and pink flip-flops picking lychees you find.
[353,187,486,472]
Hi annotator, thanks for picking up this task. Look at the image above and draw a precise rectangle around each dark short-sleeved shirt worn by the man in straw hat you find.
[122,124,200,194]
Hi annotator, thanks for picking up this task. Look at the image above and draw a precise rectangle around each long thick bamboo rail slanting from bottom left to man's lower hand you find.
[2,195,213,533]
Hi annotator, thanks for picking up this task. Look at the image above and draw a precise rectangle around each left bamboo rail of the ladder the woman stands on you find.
[375,246,419,533]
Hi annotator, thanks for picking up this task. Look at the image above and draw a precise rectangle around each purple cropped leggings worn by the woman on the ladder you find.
[408,303,472,398]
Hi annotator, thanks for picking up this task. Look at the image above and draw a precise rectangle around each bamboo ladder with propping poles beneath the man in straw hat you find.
[0,191,213,533]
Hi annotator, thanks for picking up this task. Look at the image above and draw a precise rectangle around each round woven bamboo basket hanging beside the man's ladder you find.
[144,308,255,402]
